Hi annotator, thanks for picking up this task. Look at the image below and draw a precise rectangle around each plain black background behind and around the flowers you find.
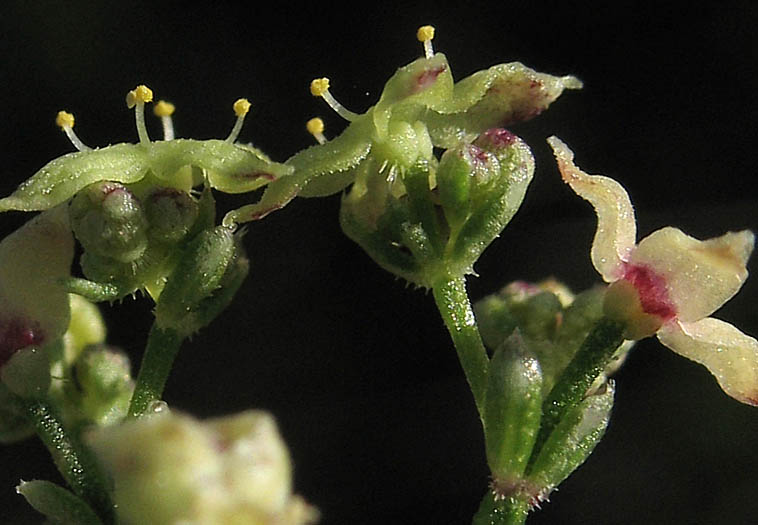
[0,0,758,524]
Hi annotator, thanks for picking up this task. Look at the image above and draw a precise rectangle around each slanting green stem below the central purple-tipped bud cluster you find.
[433,277,489,418]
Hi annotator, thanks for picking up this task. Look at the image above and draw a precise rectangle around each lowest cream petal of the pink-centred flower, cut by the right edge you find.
[658,317,758,406]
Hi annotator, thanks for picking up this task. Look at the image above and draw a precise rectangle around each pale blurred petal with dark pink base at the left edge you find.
[0,204,74,365]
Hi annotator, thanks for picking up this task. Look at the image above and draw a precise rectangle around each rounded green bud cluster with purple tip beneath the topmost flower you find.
[340,129,534,288]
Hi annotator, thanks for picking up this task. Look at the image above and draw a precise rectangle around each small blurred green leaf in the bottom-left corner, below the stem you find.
[16,480,102,525]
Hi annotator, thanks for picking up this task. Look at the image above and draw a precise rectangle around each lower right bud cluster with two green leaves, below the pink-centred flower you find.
[474,280,631,506]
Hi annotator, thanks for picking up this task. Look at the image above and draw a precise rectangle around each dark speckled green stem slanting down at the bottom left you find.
[19,399,113,523]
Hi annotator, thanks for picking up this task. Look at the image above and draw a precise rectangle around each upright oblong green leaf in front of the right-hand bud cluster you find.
[484,331,542,480]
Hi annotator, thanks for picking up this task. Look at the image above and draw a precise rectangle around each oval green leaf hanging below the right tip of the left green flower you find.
[155,226,247,337]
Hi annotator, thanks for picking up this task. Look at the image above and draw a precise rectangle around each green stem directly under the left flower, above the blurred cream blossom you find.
[129,324,184,418]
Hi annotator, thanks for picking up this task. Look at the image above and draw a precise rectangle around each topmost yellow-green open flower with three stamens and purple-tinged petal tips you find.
[224,26,581,224]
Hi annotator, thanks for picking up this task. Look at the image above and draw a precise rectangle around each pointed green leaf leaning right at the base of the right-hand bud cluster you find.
[527,382,614,498]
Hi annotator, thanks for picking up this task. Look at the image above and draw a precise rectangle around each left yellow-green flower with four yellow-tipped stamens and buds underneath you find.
[0,86,282,301]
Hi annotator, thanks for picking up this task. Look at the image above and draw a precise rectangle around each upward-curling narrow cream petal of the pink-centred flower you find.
[547,137,637,282]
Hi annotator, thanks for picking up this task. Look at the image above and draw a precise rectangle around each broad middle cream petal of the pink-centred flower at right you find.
[629,227,754,323]
